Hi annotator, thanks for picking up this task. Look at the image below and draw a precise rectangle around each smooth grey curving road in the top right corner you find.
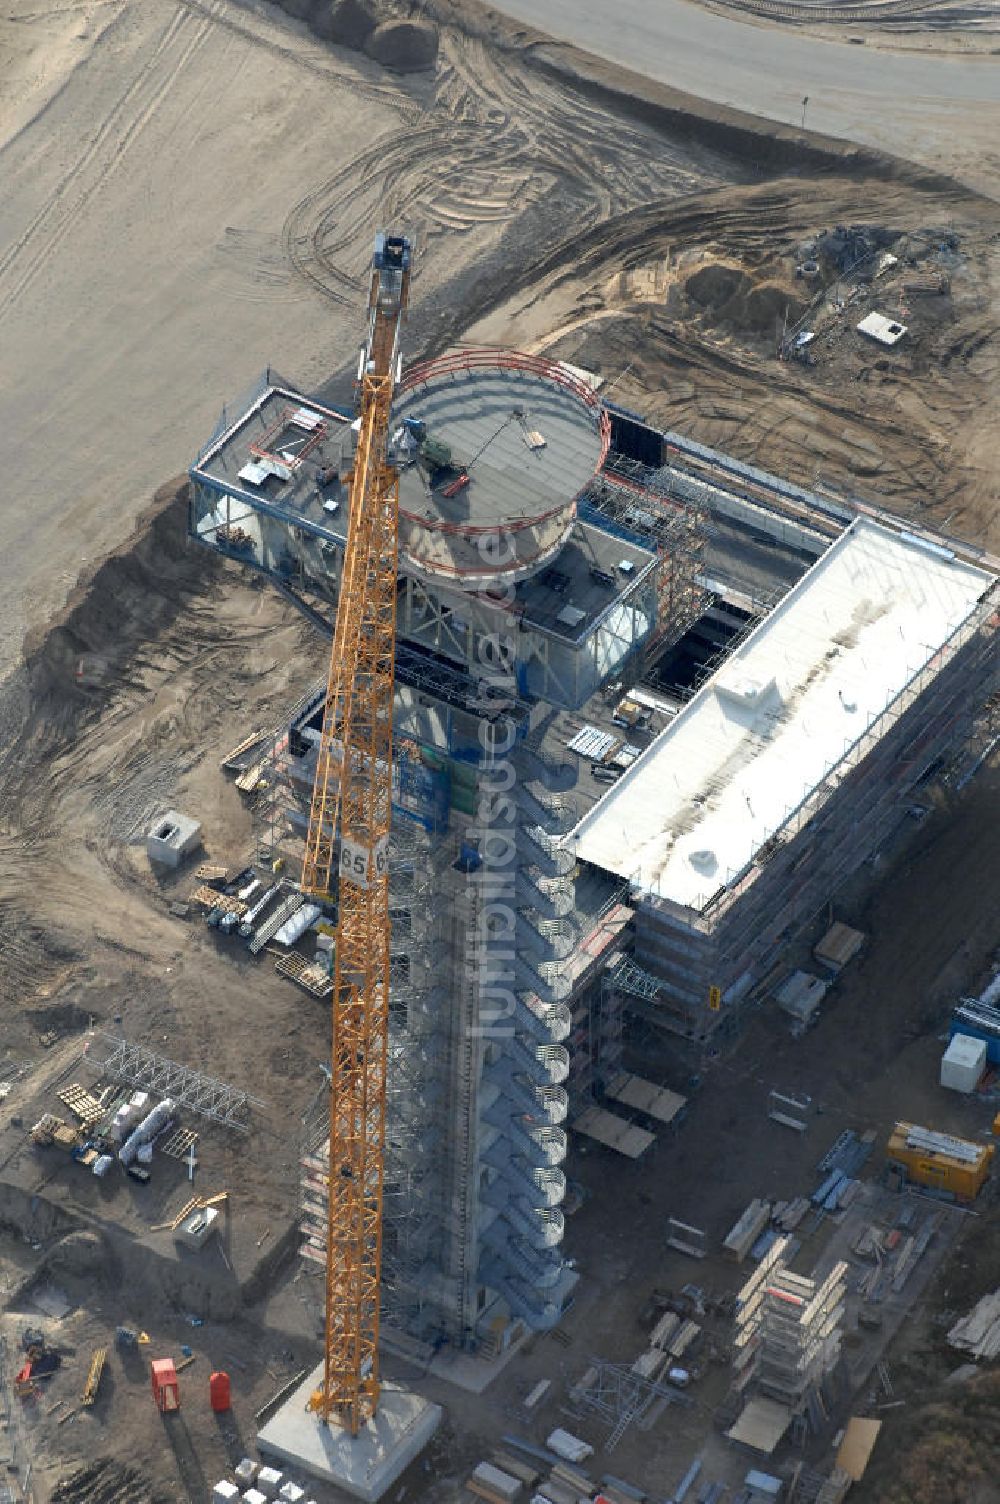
[490,0,1000,197]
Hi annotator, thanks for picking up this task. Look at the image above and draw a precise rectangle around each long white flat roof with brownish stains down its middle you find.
[568,519,994,910]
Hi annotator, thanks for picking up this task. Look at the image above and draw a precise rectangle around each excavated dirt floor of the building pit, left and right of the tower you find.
[0,487,1000,1504]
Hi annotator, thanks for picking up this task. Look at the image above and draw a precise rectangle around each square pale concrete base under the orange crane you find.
[257,1363,444,1504]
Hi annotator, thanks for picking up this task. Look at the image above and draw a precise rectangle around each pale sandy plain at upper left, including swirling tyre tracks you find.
[0,0,738,674]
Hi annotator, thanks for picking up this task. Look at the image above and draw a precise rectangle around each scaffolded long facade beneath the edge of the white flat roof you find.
[631,587,998,1035]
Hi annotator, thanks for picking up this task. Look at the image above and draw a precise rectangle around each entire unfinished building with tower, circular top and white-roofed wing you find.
[189,350,995,1352]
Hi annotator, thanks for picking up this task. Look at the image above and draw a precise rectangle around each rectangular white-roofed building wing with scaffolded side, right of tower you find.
[571,517,997,1039]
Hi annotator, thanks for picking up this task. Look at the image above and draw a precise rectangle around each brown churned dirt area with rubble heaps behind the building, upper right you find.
[472,177,1000,547]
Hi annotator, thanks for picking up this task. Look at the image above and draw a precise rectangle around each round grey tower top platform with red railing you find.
[389,349,609,590]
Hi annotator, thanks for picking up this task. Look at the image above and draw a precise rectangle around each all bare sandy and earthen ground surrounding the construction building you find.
[0,0,1000,1504]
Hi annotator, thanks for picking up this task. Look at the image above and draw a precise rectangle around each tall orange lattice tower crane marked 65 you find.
[301,233,411,1436]
